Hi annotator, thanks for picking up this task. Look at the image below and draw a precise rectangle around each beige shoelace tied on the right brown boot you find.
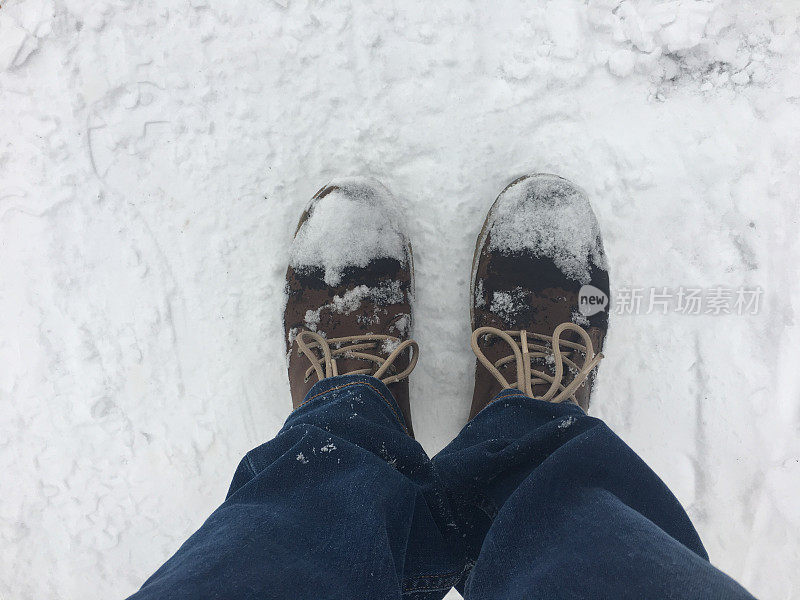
[472,323,603,404]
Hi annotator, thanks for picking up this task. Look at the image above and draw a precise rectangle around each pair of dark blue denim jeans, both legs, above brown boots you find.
[131,375,752,600]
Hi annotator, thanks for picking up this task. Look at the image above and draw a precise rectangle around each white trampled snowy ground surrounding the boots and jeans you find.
[0,0,800,600]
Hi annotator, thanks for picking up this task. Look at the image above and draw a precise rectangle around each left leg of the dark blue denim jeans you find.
[131,375,464,600]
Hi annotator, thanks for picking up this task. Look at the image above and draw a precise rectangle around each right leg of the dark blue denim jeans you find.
[433,390,752,600]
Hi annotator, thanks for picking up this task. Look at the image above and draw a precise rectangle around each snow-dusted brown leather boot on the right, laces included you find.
[470,174,609,419]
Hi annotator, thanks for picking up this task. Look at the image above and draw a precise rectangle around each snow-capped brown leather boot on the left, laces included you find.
[284,177,418,434]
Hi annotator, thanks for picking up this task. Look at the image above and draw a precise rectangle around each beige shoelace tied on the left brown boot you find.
[295,331,419,385]
